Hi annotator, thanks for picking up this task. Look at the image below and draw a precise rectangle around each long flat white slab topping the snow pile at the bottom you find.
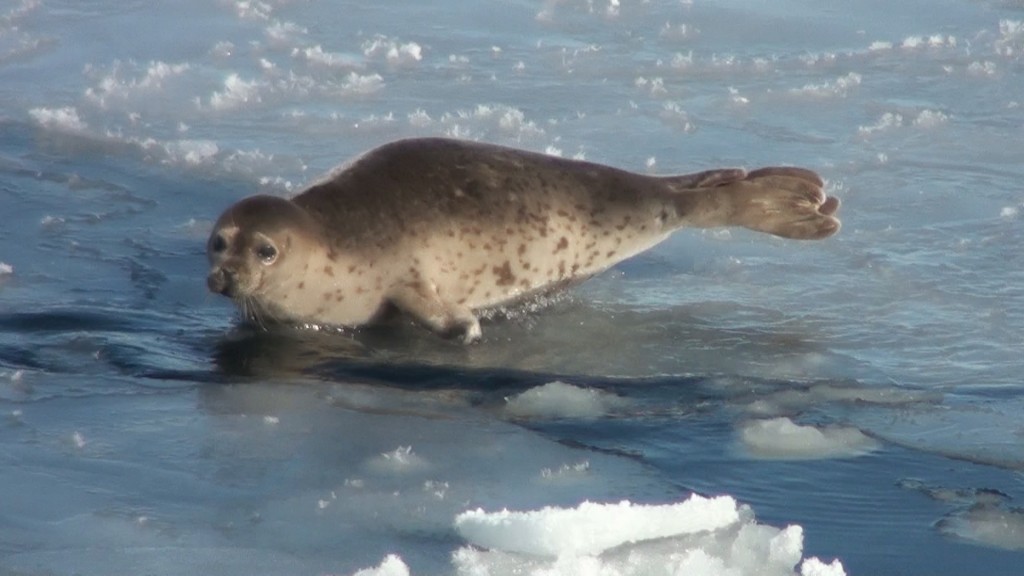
[455,494,739,558]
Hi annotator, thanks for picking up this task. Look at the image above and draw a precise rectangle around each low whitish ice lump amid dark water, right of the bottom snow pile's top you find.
[739,417,878,459]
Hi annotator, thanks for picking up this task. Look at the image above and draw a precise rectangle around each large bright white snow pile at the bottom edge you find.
[452,495,845,576]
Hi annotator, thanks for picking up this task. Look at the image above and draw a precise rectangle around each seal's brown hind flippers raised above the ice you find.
[665,167,841,240]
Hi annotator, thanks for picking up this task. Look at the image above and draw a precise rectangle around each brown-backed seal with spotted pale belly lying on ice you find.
[207,138,840,342]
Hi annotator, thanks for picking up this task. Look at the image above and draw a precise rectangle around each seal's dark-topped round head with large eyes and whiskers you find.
[206,196,317,322]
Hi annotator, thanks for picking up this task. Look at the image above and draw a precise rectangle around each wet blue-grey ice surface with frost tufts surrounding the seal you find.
[0,0,1024,575]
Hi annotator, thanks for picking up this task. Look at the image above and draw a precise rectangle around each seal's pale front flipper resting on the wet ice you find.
[387,280,481,344]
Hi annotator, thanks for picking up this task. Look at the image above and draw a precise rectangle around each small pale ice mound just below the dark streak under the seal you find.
[505,381,628,418]
